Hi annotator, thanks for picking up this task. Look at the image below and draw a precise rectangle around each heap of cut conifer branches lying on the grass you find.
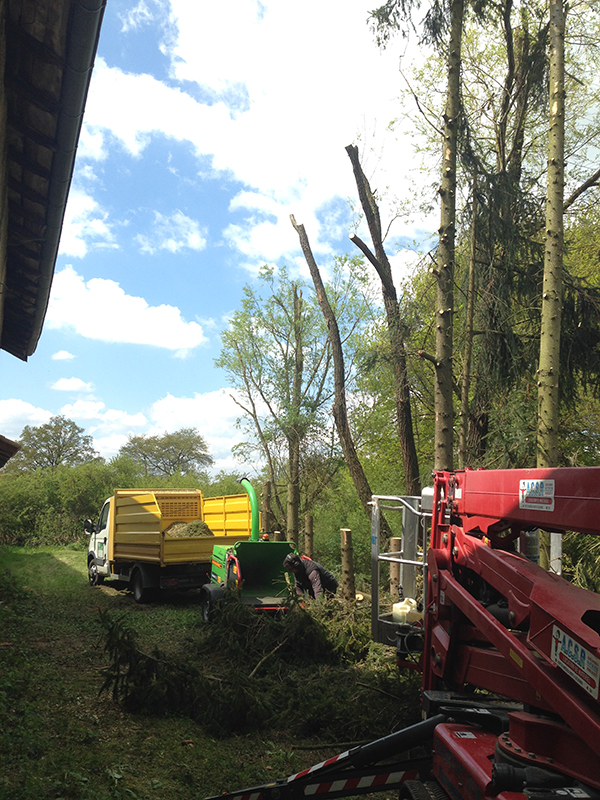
[101,595,419,742]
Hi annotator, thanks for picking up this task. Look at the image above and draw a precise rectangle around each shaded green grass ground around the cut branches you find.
[0,547,417,800]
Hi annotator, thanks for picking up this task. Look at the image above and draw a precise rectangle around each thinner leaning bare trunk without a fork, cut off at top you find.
[290,215,373,519]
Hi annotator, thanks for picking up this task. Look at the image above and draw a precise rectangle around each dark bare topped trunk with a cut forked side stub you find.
[346,145,421,495]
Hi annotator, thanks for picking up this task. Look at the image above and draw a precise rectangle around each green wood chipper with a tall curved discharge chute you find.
[200,478,294,621]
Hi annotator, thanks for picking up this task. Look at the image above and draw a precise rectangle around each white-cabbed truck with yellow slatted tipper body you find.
[85,489,252,603]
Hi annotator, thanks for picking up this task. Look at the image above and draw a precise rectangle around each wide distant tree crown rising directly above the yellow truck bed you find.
[119,428,213,477]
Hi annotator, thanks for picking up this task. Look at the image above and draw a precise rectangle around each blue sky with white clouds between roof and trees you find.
[0,0,436,476]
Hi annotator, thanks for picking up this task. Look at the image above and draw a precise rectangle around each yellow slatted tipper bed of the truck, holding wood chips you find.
[108,489,252,566]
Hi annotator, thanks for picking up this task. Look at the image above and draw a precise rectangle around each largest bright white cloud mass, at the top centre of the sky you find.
[78,0,432,270]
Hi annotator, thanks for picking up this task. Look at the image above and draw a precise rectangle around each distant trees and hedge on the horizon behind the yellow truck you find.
[0,416,238,546]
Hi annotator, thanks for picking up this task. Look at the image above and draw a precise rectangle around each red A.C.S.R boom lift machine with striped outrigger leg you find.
[205,467,600,800]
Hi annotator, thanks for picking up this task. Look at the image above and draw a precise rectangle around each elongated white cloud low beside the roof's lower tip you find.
[46,266,208,355]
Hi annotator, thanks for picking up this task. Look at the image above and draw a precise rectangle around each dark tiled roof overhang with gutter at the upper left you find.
[0,0,106,361]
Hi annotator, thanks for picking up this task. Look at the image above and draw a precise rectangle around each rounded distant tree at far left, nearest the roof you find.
[3,416,101,473]
